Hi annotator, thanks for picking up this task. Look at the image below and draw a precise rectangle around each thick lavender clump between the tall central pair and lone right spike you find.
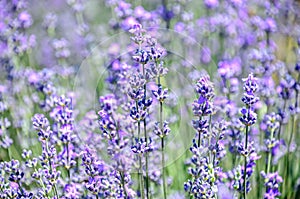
[184,76,227,198]
